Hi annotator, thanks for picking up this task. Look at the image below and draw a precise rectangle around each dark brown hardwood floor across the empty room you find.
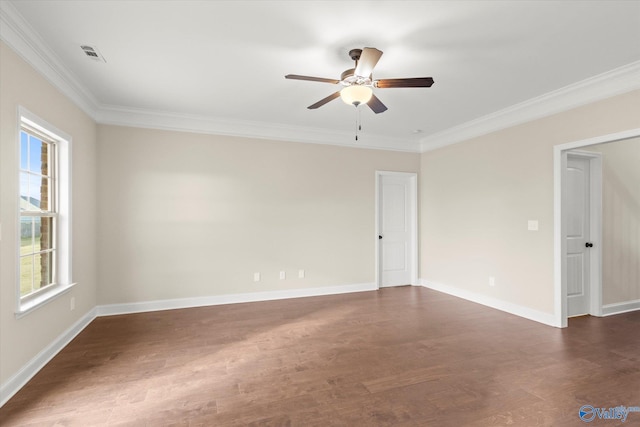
[0,287,640,427]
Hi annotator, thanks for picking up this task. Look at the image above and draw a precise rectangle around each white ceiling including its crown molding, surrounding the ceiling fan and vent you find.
[1,0,640,151]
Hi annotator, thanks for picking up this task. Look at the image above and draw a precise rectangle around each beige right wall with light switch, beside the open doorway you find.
[420,91,640,313]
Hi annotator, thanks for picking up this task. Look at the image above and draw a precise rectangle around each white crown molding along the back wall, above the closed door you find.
[97,105,419,153]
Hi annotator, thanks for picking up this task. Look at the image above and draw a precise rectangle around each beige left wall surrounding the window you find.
[0,42,97,384]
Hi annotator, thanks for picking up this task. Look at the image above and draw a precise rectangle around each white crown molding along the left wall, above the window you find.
[0,1,98,120]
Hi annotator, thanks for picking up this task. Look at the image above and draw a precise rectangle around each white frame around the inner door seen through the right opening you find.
[560,150,602,317]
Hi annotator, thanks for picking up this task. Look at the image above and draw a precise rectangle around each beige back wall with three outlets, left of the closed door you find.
[98,125,420,304]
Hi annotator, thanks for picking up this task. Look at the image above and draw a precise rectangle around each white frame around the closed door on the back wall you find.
[374,171,418,289]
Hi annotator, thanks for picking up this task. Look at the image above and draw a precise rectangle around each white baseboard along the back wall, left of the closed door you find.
[97,283,378,316]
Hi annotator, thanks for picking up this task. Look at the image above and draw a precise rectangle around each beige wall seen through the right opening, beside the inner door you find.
[590,138,640,305]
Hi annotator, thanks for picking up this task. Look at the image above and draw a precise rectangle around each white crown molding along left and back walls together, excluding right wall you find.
[0,1,420,153]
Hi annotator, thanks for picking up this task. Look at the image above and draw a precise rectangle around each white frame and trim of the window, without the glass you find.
[15,106,74,317]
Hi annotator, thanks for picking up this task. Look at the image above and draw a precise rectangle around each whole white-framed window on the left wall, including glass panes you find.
[17,108,71,314]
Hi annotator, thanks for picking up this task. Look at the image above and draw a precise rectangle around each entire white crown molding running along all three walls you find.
[0,1,640,153]
